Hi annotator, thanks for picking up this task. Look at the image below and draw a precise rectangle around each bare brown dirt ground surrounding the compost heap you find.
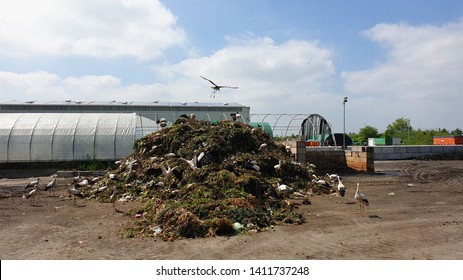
[0,160,463,260]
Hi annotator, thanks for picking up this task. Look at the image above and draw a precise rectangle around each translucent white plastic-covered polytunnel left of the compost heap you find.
[0,113,158,162]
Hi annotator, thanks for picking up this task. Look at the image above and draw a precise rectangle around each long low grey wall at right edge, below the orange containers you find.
[371,145,463,160]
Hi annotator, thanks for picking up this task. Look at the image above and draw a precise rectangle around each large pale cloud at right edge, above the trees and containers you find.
[341,20,463,129]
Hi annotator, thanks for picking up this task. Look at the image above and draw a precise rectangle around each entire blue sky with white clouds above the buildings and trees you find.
[0,0,463,133]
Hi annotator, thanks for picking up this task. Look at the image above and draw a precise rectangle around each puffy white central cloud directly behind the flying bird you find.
[154,37,334,113]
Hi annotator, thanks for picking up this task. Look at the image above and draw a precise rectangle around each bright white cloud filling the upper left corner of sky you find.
[0,0,185,60]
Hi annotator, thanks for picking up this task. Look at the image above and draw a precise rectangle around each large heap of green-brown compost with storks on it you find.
[89,119,331,240]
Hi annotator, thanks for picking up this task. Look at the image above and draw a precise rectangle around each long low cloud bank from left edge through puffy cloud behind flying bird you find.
[0,37,335,124]
